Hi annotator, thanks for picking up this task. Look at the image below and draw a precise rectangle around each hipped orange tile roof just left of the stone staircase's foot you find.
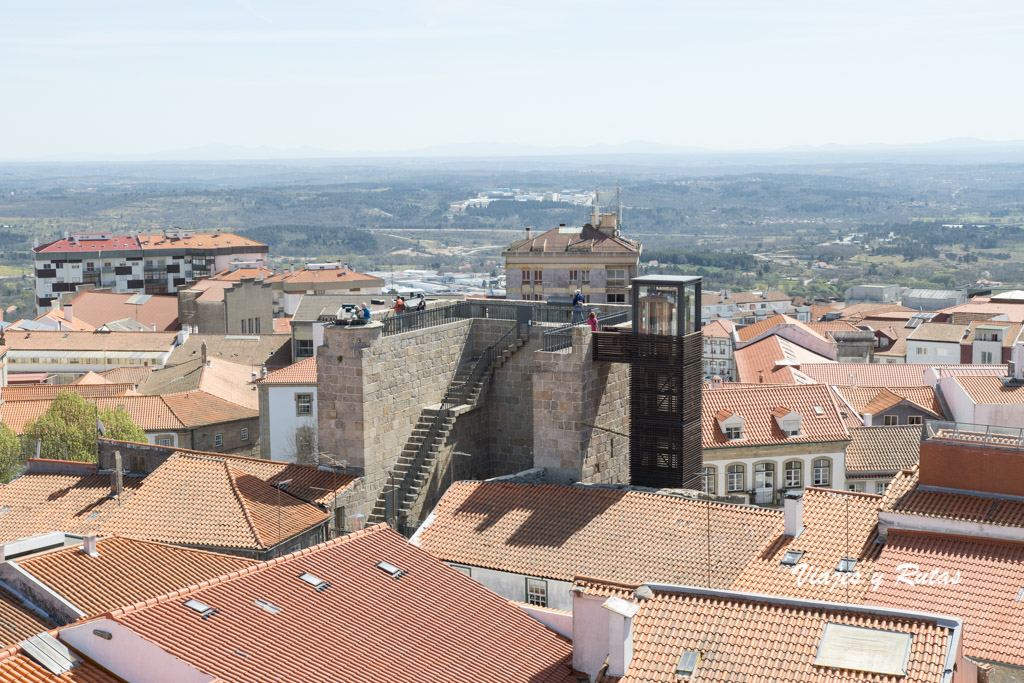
[103,455,327,550]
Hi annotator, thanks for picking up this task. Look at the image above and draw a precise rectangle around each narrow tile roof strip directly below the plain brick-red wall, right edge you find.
[882,468,1024,528]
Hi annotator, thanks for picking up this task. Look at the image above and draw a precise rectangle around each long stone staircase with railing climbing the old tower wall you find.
[369,328,526,523]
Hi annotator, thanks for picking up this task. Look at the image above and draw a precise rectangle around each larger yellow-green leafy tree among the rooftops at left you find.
[25,391,146,462]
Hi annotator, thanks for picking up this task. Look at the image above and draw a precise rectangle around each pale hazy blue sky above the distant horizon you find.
[0,0,1024,160]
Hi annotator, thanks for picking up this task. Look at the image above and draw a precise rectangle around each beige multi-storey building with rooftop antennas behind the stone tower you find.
[504,213,641,303]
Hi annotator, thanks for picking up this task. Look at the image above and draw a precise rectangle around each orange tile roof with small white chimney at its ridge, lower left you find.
[16,537,257,618]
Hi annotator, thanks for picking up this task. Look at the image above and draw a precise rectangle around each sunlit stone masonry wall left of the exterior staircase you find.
[316,319,472,514]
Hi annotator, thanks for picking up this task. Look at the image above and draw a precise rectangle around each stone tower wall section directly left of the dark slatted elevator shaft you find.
[532,326,629,483]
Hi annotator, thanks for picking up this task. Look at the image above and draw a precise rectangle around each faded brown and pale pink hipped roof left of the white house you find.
[138,358,259,411]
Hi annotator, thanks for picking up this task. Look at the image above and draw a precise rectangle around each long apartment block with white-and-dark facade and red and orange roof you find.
[33,228,268,313]
